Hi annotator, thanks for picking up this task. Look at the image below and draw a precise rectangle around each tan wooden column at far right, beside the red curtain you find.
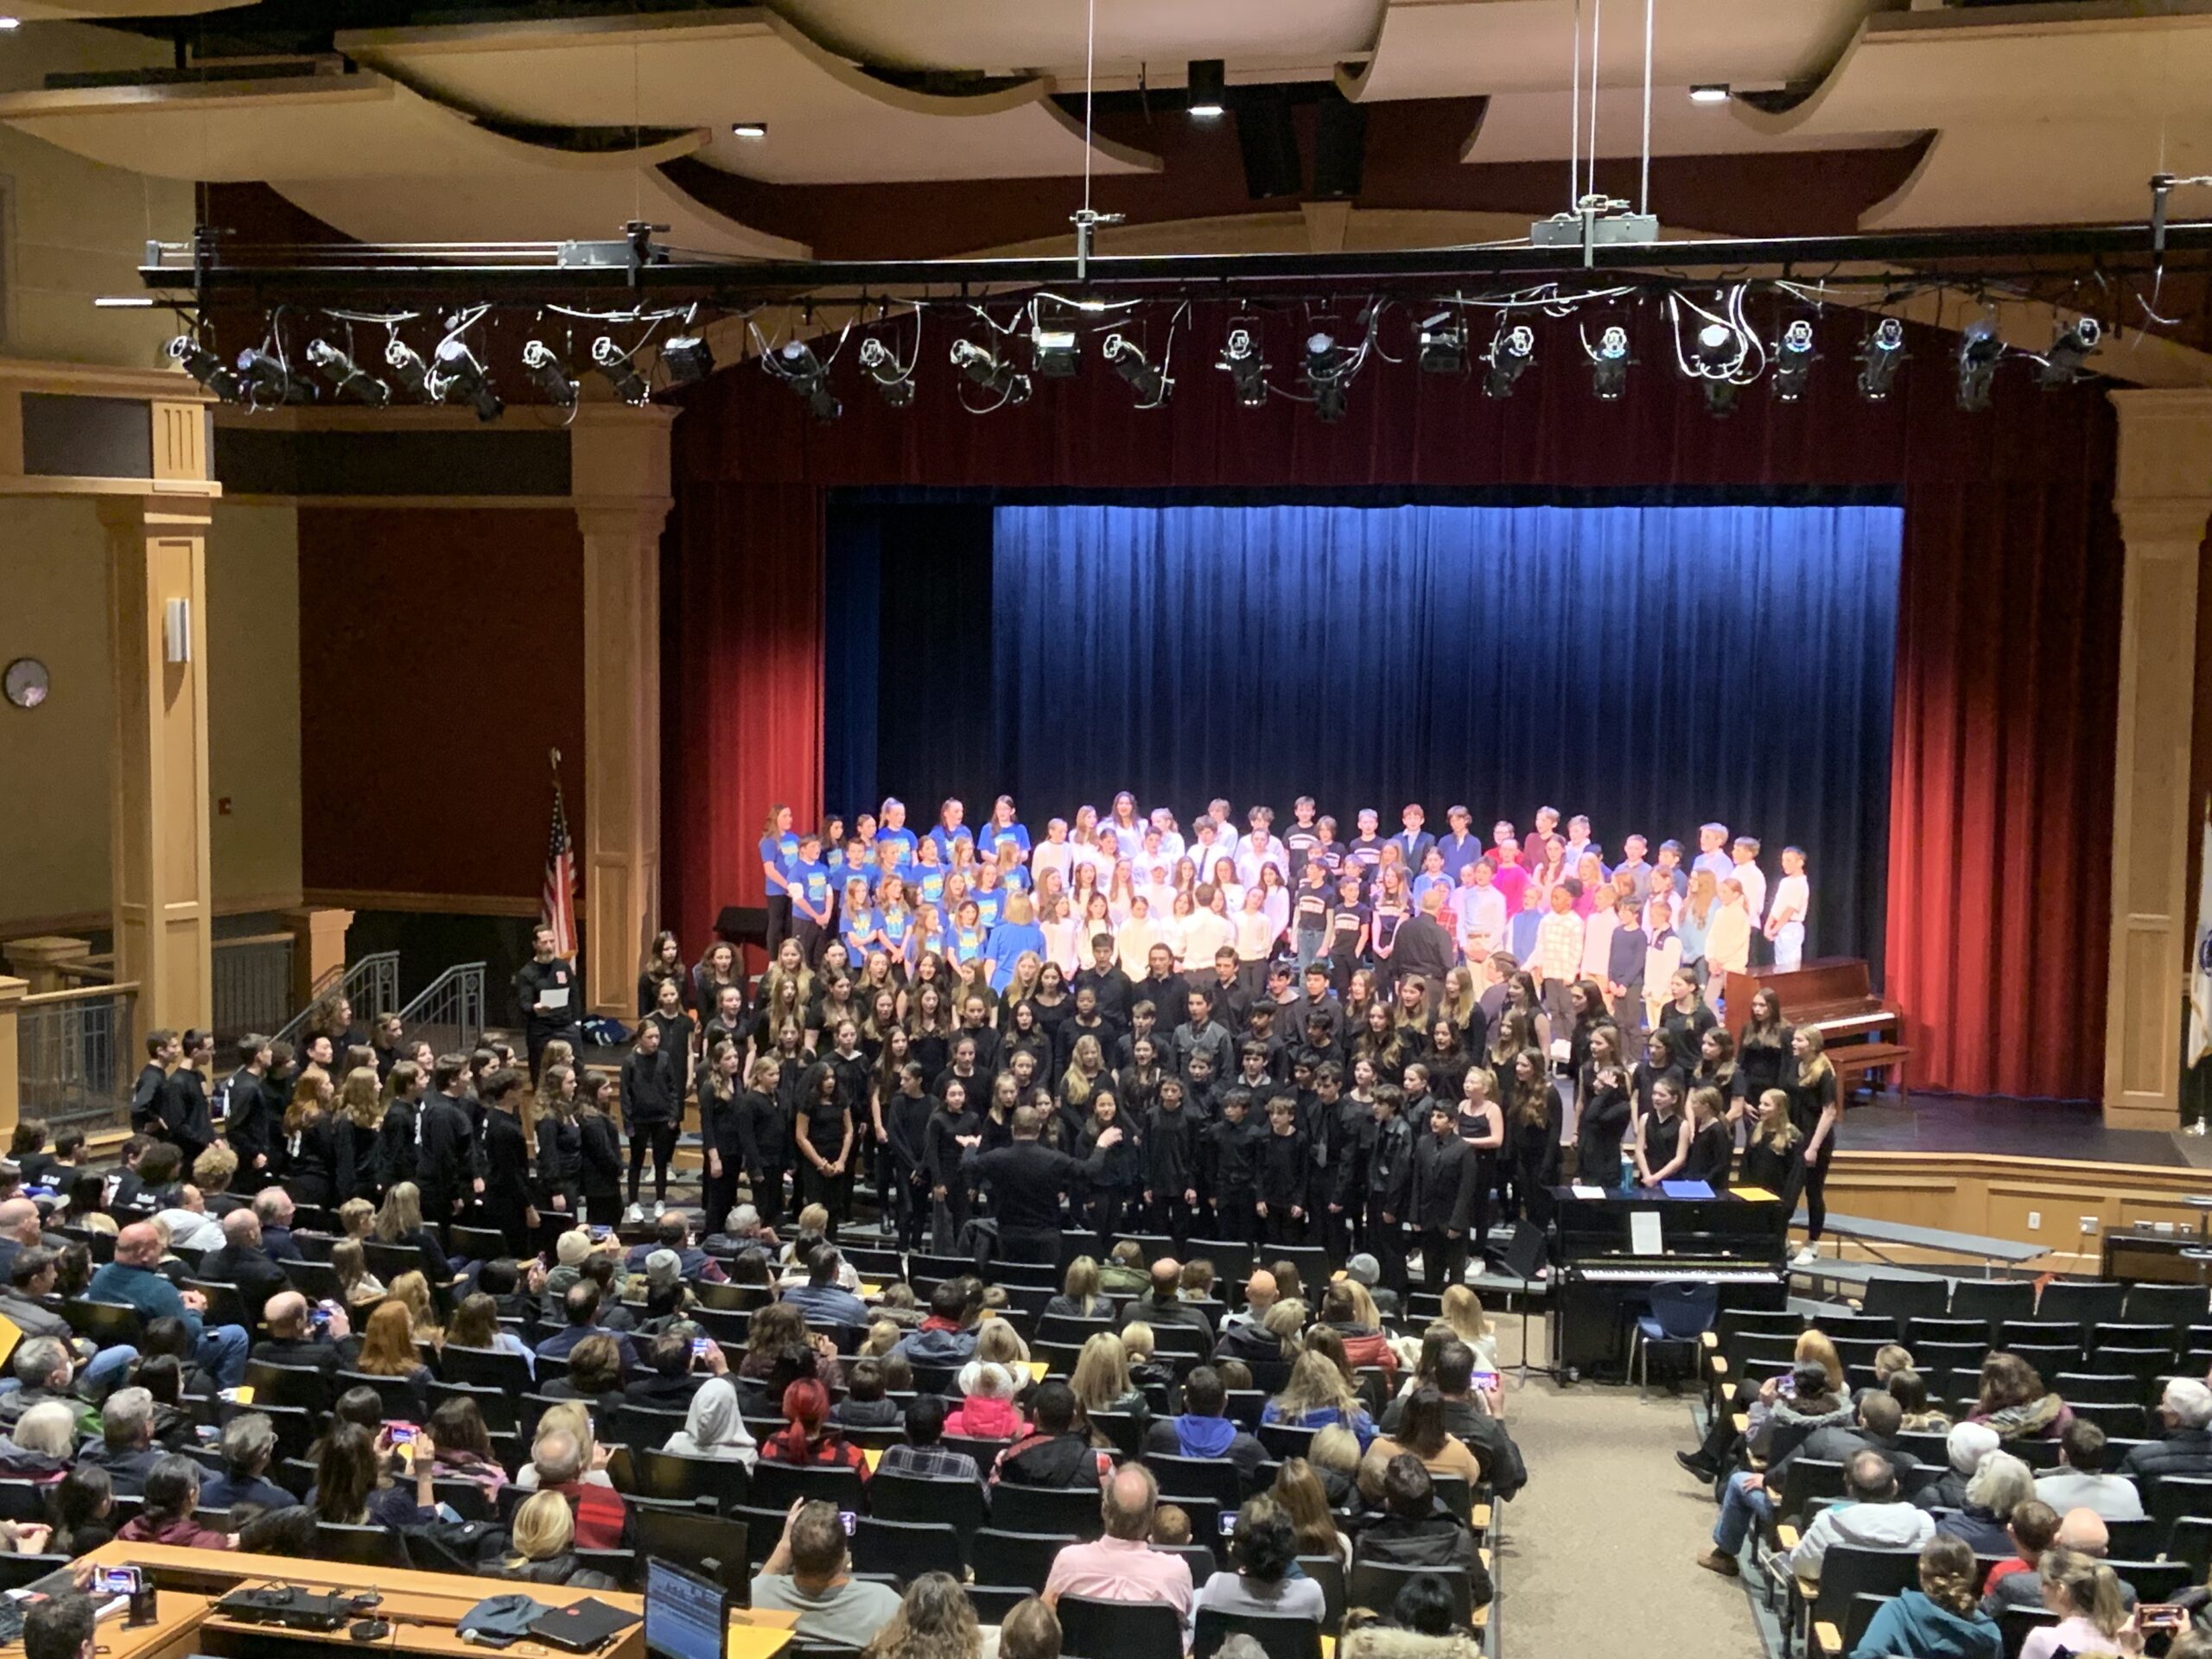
[2104,390,2212,1128]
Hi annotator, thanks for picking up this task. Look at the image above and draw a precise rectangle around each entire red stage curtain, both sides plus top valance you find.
[664,305,2119,1097]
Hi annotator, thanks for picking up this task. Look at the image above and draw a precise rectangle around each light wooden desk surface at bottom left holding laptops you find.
[78,1540,646,1659]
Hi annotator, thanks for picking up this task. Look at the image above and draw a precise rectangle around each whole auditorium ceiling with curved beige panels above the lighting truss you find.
[0,0,2212,257]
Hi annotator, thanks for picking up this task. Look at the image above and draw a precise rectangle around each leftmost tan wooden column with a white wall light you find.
[99,493,213,1048]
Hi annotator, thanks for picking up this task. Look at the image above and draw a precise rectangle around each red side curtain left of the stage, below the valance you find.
[661,485,823,953]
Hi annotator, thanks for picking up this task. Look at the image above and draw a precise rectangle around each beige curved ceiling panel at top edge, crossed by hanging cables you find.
[1340,0,1903,102]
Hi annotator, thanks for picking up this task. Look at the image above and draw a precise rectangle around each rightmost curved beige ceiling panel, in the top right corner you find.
[1734,0,2212,230]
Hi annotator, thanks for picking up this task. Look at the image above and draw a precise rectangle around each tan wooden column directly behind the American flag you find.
[569,404,675,1020]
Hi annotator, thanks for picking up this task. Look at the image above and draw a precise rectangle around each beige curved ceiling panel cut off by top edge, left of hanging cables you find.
[770,0,1385,84]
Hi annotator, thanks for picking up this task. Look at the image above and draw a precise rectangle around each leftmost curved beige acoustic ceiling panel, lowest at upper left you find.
[0,75,807,259]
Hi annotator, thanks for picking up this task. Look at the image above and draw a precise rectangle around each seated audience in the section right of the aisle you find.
[1675,1325,2212,1659]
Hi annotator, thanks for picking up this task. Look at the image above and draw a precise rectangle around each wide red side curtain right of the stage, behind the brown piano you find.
[1887,480,2121,1097]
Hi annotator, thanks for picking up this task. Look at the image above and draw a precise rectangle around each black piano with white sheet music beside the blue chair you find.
[1553,1185,1789,1380]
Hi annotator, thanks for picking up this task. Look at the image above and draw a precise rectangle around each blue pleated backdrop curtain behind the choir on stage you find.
[990,505,1903,967]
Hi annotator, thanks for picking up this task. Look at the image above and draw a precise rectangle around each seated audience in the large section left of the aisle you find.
[0,1071,1526,1659]
